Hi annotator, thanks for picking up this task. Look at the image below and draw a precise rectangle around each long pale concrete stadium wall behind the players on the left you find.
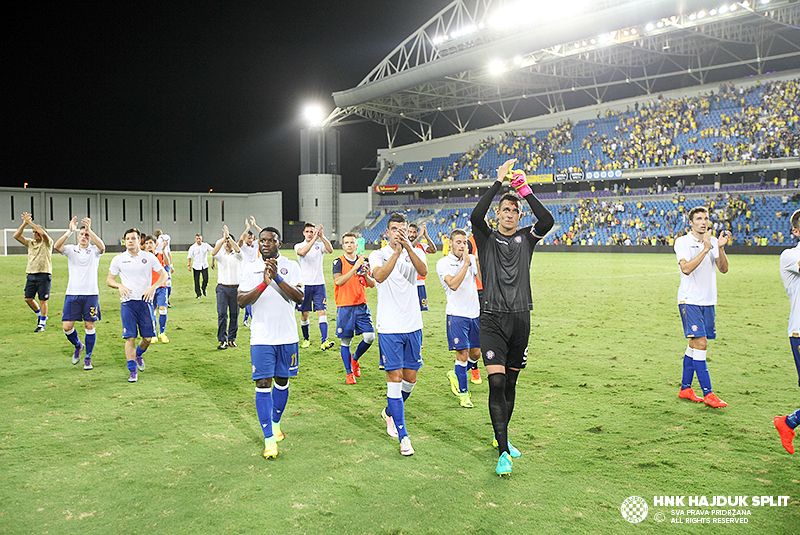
[0,188,283,253]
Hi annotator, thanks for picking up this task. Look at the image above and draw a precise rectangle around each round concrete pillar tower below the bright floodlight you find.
[297,127,342,241]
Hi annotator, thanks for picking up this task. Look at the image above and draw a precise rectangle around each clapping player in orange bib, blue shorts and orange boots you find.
[333,232,375,385]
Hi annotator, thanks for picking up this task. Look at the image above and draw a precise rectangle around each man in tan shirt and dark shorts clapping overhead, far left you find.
[14,212,53,333]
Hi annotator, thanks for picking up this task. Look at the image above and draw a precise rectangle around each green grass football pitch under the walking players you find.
[0,251,800,535]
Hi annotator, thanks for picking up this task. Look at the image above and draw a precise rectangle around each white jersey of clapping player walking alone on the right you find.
[674,232,719,306]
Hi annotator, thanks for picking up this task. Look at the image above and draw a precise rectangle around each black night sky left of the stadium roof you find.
[6,0,448,219]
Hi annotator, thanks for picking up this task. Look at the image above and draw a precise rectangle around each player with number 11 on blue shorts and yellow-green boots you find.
[238,227,303,459]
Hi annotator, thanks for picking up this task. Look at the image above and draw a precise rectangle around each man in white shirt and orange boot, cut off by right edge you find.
[772,210,800,453]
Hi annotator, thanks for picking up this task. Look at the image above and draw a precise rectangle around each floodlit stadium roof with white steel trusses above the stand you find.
[324,0,800,147]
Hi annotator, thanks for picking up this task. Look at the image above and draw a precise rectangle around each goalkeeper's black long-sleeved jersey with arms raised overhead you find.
[471,182,553,313]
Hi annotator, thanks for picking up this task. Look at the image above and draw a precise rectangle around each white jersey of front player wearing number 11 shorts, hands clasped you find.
[239,255,302,346]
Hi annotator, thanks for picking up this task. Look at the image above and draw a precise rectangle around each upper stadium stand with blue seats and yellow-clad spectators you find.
[386,80,800,185]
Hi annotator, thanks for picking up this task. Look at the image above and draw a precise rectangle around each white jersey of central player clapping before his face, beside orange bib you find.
[369,245,425,334]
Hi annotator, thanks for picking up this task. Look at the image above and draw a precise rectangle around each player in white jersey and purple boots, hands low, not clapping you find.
[106,229,167,383]
